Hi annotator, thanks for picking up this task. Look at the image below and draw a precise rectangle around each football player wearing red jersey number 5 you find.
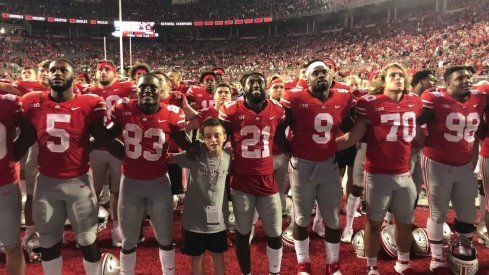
[15,58,116,275]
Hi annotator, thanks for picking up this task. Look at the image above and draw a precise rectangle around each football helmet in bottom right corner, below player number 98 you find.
[448,237,479,275]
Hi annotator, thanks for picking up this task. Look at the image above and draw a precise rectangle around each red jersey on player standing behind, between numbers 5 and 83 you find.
[84,81,137,126]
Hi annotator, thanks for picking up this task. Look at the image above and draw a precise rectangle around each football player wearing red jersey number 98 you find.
[418,66,487,274]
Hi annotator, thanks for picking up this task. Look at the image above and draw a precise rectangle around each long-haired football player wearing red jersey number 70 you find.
[336,63,422,274]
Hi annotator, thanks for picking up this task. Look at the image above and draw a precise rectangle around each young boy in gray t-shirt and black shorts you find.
[174,118,231,275]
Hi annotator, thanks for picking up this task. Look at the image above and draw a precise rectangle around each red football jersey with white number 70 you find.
[356,93,422,175]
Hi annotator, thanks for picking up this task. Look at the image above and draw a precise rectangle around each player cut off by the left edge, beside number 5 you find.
[0,95,25,275]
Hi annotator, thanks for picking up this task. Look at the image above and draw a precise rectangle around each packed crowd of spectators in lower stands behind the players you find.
[0,1,489,84]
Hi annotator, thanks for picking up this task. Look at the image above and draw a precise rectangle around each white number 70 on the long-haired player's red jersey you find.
[380,112,416,142]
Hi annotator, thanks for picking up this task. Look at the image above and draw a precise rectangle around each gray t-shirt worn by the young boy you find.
[175,149,231,233]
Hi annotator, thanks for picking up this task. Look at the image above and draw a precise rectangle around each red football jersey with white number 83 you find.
[112,98,186,180]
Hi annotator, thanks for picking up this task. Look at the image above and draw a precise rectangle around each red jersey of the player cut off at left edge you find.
[0,95,22,186]
